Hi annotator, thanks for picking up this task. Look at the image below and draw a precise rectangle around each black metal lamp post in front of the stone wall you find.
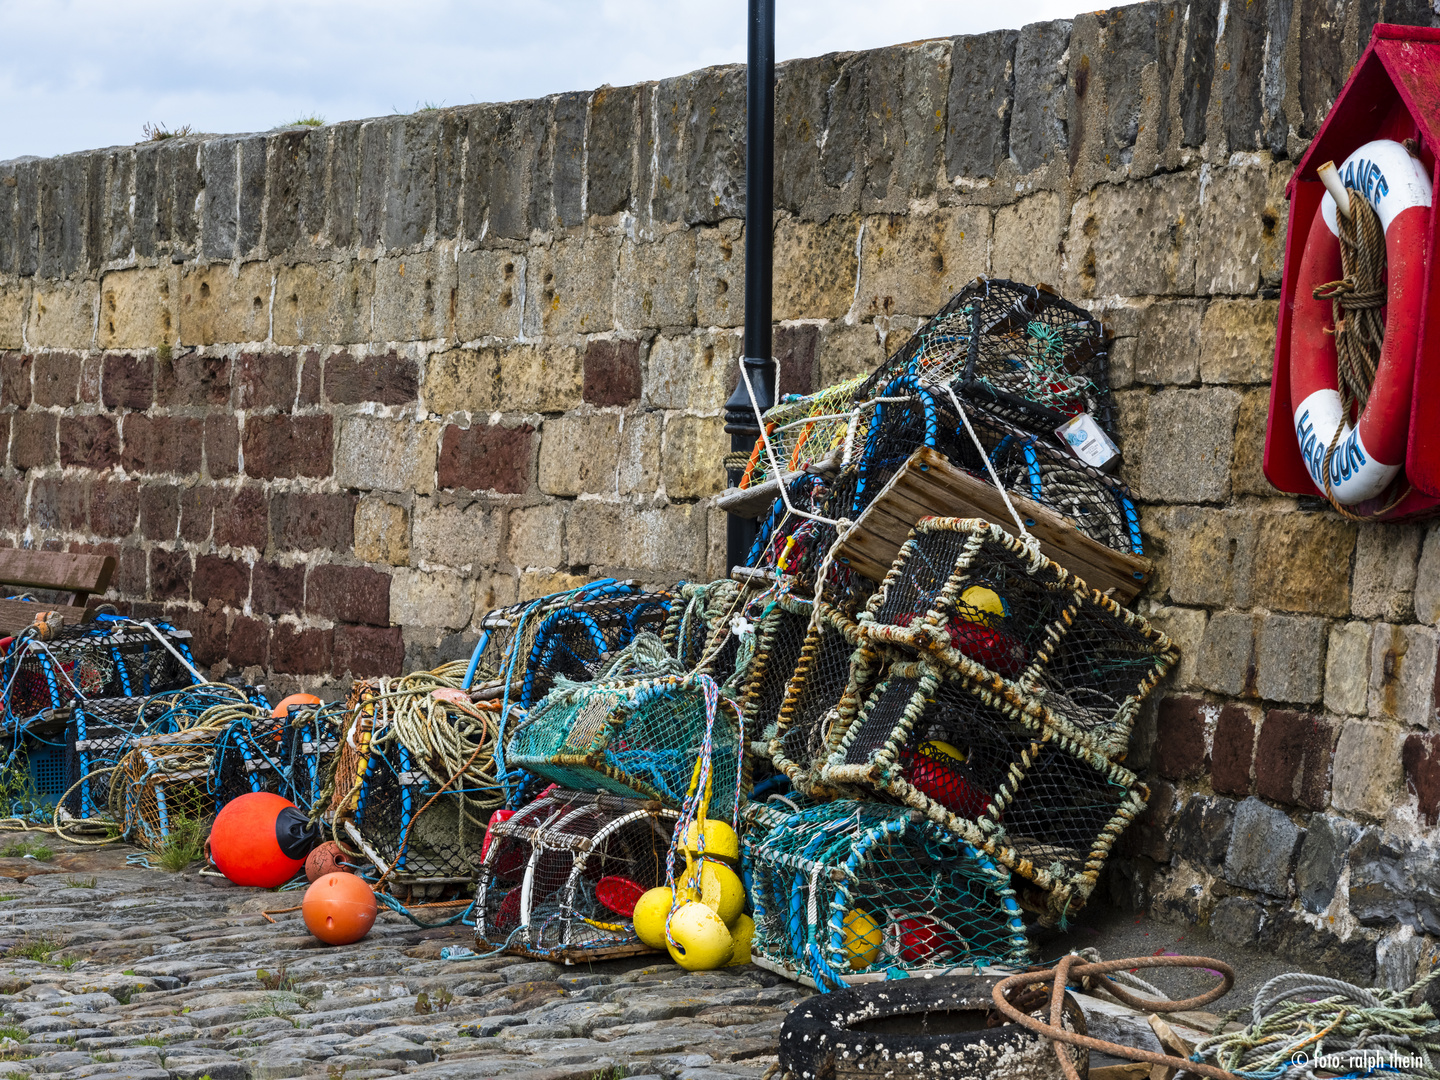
[724,0,776,567]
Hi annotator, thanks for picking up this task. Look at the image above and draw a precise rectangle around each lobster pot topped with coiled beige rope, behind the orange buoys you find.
[329,664,504,897]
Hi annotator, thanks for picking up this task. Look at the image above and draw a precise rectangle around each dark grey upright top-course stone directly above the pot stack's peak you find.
[945,30,1032,182]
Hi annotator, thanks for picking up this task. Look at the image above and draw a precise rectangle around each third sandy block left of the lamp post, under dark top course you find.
[524,236,622,337]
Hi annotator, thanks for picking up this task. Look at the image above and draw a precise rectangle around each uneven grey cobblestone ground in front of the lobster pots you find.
[0,834,809,1080]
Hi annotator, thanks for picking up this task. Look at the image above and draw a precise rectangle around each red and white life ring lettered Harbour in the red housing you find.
[1290,138,1431,505]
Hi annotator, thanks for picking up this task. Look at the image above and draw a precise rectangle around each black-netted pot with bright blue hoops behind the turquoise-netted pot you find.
[520,592,671,708]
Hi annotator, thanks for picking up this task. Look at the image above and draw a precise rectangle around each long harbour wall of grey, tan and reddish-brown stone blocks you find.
[0,0,1440,982]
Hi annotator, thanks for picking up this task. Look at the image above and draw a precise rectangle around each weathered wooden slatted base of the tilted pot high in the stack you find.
[835,448,1152,603]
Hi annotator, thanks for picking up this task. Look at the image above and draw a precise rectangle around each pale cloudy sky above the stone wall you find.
[0,0,1080,160]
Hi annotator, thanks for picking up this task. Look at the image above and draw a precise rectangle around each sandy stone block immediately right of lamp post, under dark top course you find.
[771,215,861,320]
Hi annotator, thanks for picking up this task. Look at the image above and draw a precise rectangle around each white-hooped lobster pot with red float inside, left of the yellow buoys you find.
[475,789,678,963]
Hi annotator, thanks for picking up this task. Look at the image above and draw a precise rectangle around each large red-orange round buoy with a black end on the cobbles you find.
[210,791,320,888]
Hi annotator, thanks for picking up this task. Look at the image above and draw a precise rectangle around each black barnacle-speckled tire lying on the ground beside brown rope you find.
[780,976,1089,1080]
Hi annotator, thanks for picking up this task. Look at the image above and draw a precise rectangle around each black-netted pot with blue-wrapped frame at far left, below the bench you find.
[0,615,194,723]
